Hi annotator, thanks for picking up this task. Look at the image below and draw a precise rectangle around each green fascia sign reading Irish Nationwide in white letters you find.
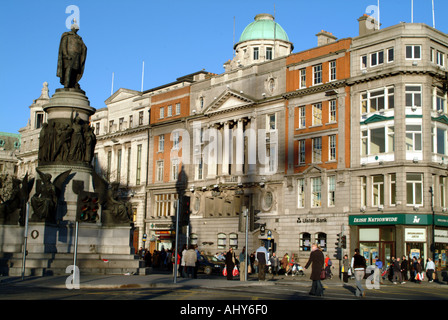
[349,214,436,226]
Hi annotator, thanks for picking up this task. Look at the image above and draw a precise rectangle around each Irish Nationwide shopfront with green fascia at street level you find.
[349,214,448,268]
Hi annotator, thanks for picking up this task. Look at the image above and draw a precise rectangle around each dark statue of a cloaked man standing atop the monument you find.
[56,22,87,89]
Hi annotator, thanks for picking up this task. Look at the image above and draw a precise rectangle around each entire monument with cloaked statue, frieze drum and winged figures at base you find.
[0,20,140,275]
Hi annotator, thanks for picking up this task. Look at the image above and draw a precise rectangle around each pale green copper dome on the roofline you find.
[239,13,289,42]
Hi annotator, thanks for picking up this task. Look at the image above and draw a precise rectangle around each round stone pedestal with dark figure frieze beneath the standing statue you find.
[27,88,132,254]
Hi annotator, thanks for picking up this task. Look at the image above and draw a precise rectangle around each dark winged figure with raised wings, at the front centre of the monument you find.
[31,168,71,223]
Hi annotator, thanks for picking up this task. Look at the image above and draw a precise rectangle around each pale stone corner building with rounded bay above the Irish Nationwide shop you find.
[347,16,448,265]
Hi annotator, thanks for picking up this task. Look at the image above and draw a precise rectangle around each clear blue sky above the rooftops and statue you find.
[0,0,448,133]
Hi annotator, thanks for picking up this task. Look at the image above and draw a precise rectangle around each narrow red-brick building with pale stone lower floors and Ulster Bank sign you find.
[283,31,351,259]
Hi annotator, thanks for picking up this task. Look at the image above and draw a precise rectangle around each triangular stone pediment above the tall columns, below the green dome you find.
[204,90,255,115]
